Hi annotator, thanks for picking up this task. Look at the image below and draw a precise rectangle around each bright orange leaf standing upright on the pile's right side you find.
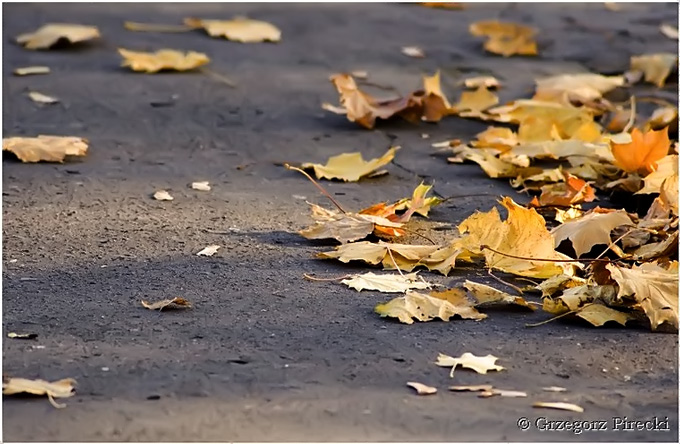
[611,127,671,175]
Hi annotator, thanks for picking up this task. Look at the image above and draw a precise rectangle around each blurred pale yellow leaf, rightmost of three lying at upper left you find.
[184,17,281,43]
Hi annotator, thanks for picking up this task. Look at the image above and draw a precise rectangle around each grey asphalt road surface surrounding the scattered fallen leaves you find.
[2,3,678,441]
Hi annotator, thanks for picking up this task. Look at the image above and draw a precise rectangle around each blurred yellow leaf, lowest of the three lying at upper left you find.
[118,48,210,73]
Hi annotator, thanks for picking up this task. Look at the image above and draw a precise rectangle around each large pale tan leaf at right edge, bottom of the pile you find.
[607,262,678,330]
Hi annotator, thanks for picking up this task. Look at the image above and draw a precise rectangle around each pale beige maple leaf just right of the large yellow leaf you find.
[550,210,634,257]
